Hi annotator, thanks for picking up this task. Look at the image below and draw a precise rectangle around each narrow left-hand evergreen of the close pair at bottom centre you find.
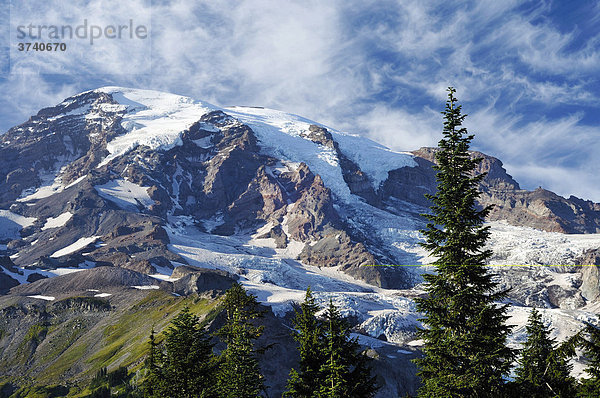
[284,287,325,398]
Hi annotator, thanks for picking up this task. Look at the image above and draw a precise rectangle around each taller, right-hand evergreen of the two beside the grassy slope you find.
[217,283,265,398]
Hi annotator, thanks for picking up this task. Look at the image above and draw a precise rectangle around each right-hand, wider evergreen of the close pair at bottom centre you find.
[317,300,378,398]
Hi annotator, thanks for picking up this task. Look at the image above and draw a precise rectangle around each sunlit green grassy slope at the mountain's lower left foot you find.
[0,291,218,398]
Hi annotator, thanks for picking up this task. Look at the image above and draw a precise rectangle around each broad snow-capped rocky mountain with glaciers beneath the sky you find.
[0,87,600,394]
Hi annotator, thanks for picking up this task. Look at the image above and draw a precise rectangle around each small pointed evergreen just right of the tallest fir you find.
[515,308,575,398]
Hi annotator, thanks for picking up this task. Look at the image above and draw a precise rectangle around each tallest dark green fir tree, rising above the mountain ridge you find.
[416,87,514,398]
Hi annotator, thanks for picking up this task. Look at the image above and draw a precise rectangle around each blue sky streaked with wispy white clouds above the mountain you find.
[0,0,600,202]
